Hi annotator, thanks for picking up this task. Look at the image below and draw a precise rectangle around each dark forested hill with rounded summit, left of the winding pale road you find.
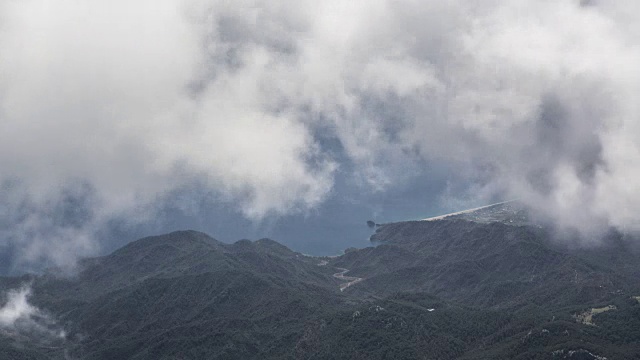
[1,231,343,359]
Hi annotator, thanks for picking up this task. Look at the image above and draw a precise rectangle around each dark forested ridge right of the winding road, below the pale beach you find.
[334,219,640,308]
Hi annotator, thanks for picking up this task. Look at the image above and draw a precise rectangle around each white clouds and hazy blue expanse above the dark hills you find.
[0,0,640,271]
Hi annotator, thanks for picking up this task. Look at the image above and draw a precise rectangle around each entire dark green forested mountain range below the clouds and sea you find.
[0,204,640,359]
